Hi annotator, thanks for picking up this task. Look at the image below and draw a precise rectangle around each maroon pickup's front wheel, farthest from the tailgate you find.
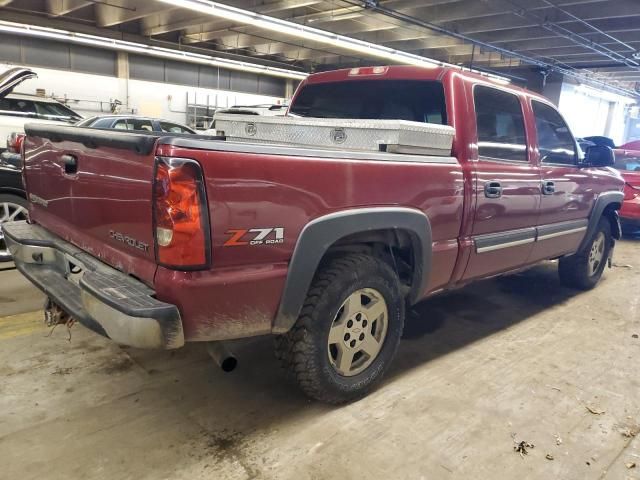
[558,217,613,290]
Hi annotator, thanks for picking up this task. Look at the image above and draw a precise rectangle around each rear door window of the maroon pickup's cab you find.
[473,85,527,162]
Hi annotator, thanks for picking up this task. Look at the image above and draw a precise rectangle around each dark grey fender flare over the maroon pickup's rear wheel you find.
[272,207,432,333]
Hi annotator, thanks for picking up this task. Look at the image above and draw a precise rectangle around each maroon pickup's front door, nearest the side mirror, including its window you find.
[531,100,599,261]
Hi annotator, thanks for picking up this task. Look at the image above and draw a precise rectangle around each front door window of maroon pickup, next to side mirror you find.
[531,100,578,165]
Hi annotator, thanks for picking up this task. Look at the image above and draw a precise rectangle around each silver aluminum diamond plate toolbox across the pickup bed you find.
[216,114,454,155]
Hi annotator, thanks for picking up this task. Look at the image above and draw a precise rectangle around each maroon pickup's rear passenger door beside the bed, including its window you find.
[464,85,540,279]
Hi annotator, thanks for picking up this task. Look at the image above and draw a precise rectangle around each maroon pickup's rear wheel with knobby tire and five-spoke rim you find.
[276,254,404,404]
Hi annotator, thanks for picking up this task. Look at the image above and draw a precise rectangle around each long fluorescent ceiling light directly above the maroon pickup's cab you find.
[159,0,444,68]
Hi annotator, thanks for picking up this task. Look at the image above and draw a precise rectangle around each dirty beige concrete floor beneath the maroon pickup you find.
[0,239,640,480]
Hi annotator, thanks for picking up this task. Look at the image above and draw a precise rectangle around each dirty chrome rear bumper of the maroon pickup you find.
[3,221,184,349]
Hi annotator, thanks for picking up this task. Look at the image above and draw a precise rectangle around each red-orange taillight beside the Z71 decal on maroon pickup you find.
[153,157,210,270]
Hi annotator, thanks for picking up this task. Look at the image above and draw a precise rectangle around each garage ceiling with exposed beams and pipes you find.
[0,0,640,95]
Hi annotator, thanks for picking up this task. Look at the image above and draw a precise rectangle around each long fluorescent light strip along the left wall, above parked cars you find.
[0,20,307,80]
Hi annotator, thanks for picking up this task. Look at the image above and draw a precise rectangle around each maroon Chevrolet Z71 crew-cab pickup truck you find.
[4,66,624,403]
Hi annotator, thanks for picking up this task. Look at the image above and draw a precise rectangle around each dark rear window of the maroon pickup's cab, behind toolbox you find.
[289,80,447,125]
